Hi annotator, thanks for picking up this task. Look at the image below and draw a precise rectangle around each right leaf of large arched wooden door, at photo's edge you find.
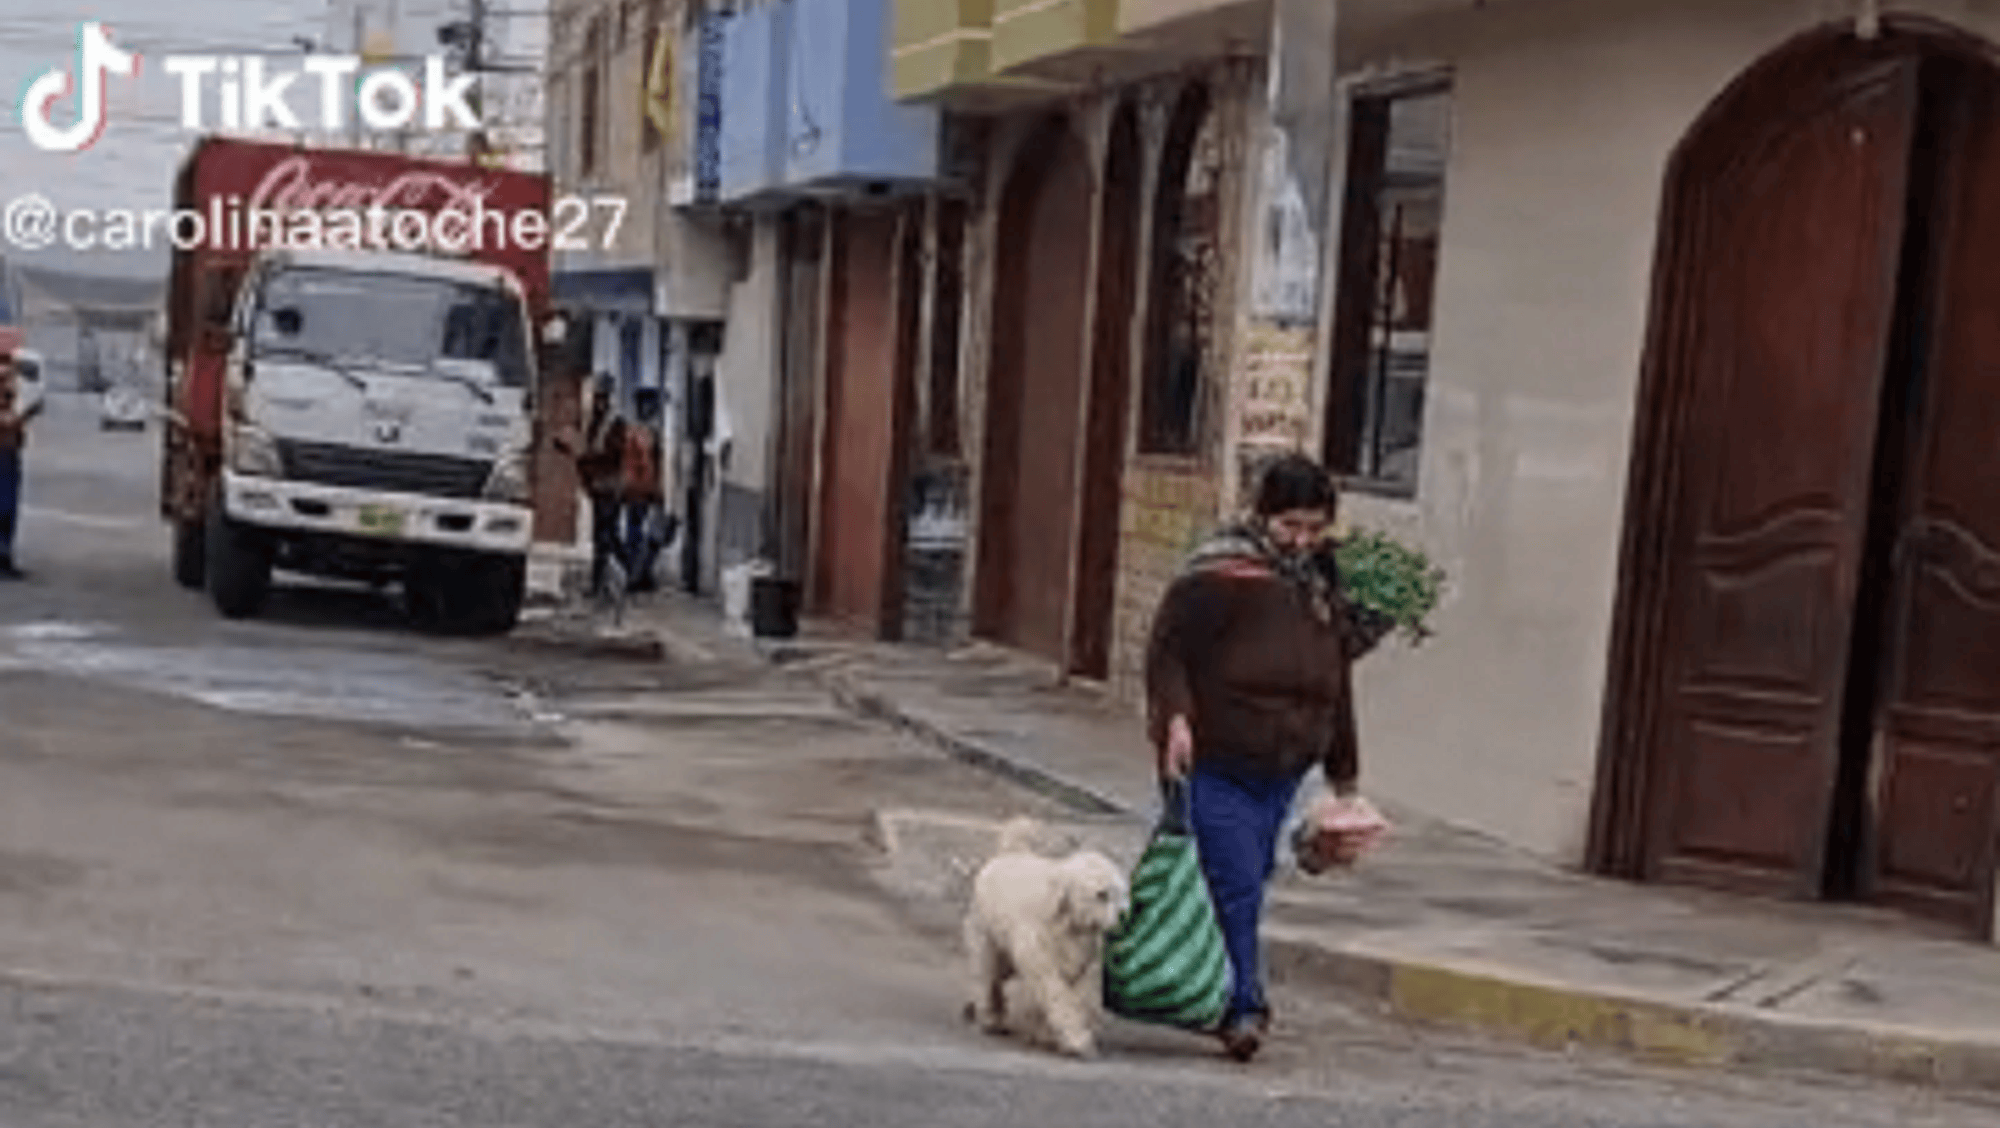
[1872,60,2000,936]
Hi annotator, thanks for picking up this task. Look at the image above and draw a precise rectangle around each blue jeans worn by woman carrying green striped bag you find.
[1188,766,1300,1022]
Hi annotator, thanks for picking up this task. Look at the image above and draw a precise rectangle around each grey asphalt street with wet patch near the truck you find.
[0,390,2000,1128]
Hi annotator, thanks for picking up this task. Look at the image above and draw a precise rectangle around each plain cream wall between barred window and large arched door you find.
[1342,0,2000,862]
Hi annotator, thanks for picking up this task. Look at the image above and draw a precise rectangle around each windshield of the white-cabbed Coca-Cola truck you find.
[254,266,528,388]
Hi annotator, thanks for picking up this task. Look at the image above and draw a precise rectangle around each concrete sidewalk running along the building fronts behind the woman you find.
[604,596,2000,1090]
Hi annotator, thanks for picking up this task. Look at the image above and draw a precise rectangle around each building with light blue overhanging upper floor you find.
[656,0,942,616]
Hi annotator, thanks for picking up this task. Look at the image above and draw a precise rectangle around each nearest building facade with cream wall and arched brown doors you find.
[892,0,2000,936]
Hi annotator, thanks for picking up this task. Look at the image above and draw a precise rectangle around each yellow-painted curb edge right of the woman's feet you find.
[1266,934,2000,1090]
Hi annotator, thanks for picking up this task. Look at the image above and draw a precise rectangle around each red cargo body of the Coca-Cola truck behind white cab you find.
[160,138,568,524]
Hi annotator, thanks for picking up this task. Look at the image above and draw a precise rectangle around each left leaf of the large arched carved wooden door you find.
[1646,54,1918,898]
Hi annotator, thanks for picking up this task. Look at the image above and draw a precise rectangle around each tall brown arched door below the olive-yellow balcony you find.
[972,118,1092,662]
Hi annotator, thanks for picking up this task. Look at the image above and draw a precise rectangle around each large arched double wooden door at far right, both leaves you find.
[1592,22,2000,936]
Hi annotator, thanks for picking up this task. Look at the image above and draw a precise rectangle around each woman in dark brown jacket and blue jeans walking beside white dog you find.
[1146,454,1360,1060]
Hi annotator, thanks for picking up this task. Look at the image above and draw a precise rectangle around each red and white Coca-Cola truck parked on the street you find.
[160,138,548,632]
